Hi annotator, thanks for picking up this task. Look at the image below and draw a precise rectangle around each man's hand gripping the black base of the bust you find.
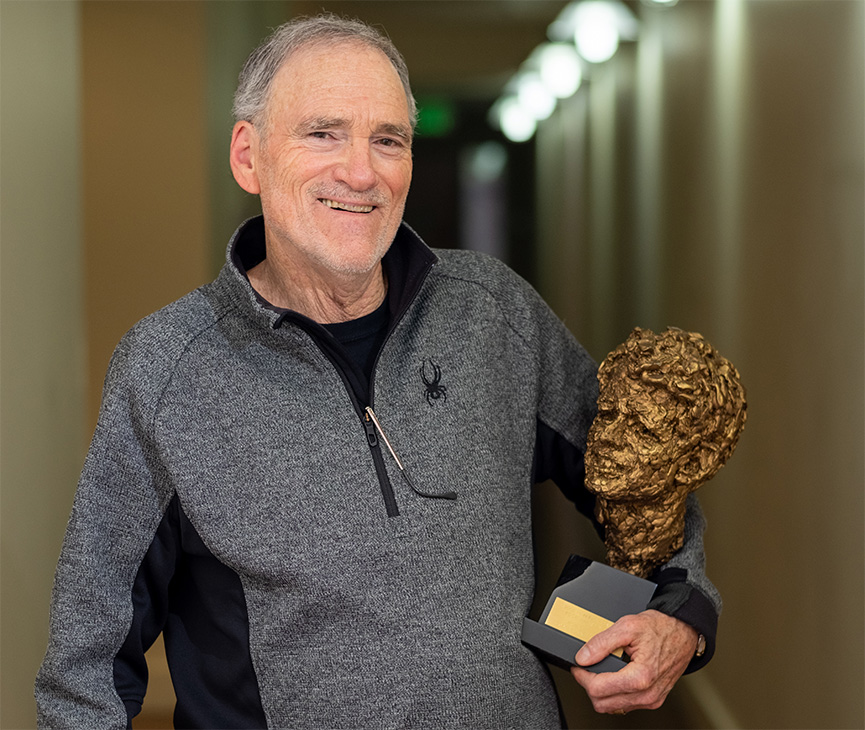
[571,611,697,714]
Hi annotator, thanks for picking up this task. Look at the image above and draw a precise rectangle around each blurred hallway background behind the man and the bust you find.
[0,0,865,728]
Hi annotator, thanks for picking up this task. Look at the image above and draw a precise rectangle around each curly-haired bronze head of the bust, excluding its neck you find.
[586,328,745,502]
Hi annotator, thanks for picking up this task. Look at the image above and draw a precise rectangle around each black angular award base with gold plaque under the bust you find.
[522,555,656,672]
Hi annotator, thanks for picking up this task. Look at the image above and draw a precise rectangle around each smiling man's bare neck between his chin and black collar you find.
[247,250,387,324]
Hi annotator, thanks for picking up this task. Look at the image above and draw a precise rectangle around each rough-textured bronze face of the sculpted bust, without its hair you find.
[586,364,688,501]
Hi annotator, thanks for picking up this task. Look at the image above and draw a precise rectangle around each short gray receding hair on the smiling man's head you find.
[232,13,417,131]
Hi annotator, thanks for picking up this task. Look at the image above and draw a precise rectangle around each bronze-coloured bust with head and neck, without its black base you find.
[586,328,746,577]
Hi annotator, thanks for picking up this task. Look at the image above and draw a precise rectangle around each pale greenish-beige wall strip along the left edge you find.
[0,1,88,728]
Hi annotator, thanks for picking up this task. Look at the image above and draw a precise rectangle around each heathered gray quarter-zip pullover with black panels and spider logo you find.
[37,220,719,728]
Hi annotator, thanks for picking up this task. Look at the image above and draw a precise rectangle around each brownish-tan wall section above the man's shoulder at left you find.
[81,1,211,424]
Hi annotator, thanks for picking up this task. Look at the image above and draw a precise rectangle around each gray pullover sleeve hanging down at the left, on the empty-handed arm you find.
[35,335,178,728]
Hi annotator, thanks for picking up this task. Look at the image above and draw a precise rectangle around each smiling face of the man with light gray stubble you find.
[251,43,412,274]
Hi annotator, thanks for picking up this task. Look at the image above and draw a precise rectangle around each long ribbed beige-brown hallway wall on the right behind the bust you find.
[538,0,865,728]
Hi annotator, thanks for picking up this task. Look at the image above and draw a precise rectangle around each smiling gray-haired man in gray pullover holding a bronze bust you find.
[37,16,717,728]
